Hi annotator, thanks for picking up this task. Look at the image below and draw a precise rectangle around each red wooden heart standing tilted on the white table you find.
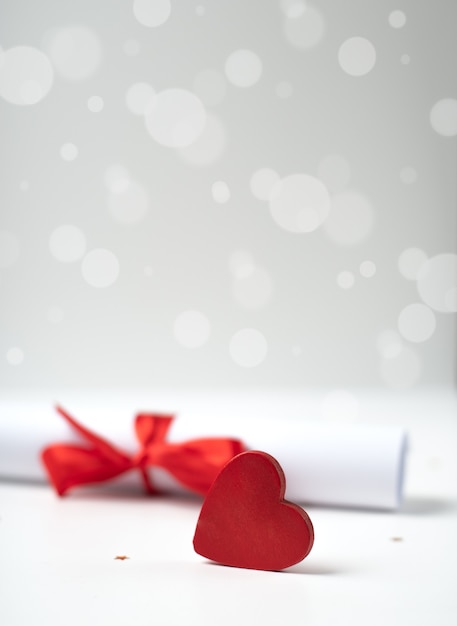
[194,451,314,570]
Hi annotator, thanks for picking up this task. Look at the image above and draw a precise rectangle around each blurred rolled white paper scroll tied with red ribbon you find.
[0,398,407,510]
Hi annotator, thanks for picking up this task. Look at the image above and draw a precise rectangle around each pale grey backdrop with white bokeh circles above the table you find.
[0,0,457,390]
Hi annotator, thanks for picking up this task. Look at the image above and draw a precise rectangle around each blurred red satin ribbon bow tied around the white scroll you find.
[41,407,245,496]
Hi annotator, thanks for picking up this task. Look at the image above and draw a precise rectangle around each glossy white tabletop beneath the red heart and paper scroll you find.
[0,391,457,626]
